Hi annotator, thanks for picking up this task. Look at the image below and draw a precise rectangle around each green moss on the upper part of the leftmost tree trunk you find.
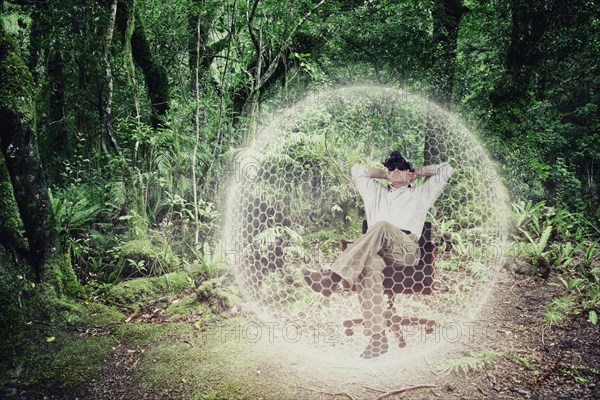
[0,27,34,121]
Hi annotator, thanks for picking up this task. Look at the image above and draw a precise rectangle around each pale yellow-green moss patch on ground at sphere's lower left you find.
[133,318,300,400]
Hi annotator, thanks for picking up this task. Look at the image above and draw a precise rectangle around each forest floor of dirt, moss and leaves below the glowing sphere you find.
[1,270,600,400]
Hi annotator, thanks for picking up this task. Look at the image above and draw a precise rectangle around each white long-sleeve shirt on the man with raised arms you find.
[352,163,452,237]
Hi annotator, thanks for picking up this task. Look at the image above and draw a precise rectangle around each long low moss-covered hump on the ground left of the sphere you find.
[106,272,192,307]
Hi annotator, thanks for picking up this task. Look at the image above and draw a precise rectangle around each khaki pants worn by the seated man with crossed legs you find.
[331,222,421,336]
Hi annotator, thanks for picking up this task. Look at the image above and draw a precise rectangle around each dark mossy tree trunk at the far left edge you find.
[0,24,57,280]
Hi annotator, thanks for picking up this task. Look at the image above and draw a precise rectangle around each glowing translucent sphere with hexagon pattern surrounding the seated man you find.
[224,86,508,354]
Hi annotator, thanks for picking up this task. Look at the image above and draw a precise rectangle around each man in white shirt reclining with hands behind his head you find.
[303,151,452,358]
